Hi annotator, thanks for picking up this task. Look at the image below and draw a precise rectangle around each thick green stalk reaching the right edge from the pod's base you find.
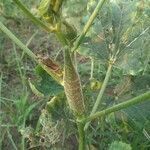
[81,91,150,122]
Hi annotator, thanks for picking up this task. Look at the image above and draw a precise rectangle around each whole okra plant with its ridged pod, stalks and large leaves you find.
[0,0,150,150]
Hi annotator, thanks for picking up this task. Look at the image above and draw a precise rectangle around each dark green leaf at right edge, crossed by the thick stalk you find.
[116,75,150,131]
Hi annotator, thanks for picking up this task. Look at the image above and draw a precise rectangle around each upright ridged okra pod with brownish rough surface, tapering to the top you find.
[63,48,85,116]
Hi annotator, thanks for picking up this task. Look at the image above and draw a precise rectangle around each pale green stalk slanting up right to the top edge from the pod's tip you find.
[71,0,107,51]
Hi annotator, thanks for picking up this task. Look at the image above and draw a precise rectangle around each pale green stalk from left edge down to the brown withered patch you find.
[0,22,37,62]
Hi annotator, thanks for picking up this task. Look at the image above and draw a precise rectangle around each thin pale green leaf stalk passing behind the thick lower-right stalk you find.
[84,63,113,130]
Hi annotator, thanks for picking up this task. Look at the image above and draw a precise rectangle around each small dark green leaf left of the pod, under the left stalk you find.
[30,66,63,96]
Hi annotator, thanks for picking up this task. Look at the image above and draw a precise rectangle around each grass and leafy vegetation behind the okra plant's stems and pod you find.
[0,0,150,150]
